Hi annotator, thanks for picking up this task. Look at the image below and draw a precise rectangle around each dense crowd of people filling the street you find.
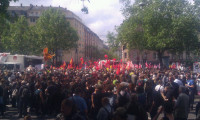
[0,68,200,120]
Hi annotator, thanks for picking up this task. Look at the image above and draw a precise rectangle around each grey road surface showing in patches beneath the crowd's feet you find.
[0,96,200,120]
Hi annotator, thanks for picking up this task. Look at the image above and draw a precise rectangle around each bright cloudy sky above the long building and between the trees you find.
[10,0,123,41]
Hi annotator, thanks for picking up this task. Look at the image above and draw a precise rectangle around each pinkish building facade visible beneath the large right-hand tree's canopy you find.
[122,46,198,64]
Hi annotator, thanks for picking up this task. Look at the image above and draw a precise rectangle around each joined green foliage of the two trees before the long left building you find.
[0,9,78,55]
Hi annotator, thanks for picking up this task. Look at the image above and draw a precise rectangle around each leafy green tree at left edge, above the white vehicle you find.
[1,16,33,54]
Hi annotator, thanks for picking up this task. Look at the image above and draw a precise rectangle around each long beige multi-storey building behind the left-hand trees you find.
[8,4,104,63]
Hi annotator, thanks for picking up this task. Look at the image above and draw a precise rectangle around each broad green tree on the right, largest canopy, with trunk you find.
[118,0,199,64]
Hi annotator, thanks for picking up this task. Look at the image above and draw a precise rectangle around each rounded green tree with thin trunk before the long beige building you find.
[35,8,78,62]
